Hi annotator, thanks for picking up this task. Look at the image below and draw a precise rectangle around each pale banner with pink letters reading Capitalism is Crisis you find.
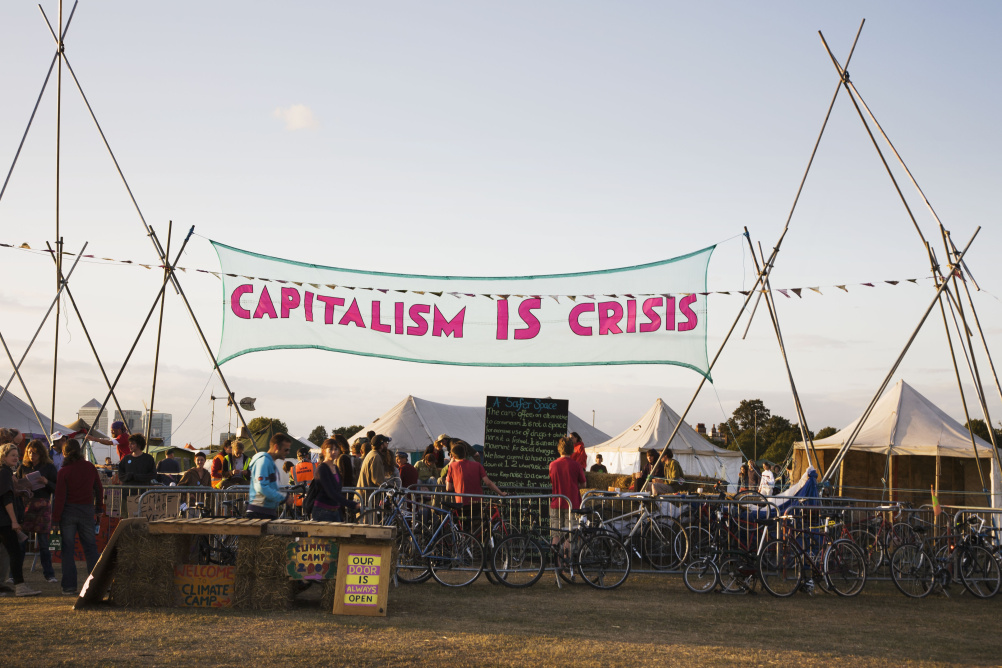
[211,241,714,378]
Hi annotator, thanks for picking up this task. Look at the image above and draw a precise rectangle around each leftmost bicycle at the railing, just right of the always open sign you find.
[361,484,484,587]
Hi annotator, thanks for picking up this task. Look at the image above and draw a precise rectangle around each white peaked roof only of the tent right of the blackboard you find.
[586,399,741,459]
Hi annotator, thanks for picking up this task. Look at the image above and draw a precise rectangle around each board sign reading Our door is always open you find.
[334,545,393,617]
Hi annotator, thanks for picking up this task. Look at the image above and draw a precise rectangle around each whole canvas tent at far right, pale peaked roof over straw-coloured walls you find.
[794,381,1000,507]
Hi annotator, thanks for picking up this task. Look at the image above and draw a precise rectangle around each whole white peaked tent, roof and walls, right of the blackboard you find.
[586,399,741,491]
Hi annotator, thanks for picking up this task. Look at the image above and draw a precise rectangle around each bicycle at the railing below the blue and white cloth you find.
[759,511,867,598]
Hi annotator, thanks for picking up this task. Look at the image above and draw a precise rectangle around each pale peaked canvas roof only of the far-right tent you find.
[794,381,992,457]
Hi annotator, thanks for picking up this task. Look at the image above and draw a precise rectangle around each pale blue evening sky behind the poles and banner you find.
[0,0,1002,443]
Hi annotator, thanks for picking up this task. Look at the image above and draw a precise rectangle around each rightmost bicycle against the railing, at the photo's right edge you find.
[891,518,1002,598]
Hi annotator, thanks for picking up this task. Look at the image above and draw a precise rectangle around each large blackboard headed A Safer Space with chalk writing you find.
[484,397,567,489]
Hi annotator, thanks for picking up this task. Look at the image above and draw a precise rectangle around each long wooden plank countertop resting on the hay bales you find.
[147,518,397,540]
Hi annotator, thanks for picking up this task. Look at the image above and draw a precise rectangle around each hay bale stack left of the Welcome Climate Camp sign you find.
[110,526,183,607]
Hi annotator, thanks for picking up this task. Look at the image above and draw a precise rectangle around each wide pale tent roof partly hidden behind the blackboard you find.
[348,396,609,452]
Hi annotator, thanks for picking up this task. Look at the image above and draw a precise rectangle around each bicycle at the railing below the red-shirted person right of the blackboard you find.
[491,509,630,589]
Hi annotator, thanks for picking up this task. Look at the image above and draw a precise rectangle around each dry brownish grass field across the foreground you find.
[0,569,1002,668]
